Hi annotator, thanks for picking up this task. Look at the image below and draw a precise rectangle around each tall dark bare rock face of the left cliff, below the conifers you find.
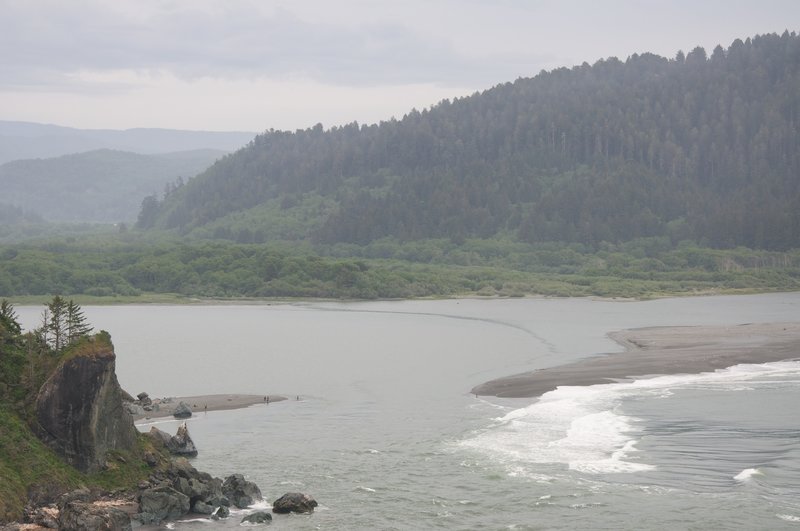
[36,334,137,472]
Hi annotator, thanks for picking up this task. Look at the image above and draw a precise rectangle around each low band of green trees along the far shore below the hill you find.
[0,236,800,302]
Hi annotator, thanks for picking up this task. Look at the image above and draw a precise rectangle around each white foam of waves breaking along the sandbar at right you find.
[459,361,800,481]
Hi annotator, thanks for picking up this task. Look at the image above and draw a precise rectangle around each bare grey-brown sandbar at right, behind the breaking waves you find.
[472,323,800,398]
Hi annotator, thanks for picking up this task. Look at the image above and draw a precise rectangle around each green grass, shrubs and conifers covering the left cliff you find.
[0,297,161,522]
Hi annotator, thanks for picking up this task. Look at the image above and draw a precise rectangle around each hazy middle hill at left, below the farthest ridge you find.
[0,149,226,224]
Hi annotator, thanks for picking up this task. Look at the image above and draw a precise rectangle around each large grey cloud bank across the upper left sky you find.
[0,0,542,88]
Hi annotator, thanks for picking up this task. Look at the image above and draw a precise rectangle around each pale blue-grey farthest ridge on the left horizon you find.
[0,121,256,164]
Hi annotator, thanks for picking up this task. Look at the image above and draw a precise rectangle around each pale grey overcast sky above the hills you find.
[0,0,800,131]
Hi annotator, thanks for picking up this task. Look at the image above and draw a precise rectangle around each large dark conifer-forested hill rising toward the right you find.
[145,32,800,249]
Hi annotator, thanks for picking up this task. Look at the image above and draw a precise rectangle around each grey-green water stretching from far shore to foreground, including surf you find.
[12,293,800,530]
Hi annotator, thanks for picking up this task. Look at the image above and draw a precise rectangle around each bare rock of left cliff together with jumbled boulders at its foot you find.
[0,332,292,531]
